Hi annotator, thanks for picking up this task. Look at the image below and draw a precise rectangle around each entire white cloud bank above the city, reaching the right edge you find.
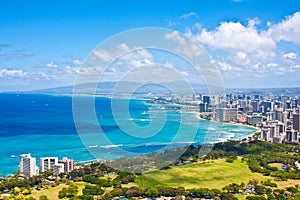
[186,12,300,83]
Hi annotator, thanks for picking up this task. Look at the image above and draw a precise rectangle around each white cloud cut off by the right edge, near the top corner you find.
[267,12,300,44]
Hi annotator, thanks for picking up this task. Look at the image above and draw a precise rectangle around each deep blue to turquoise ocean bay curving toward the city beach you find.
[0,94,255,174]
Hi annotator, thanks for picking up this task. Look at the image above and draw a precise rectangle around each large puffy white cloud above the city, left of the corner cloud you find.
[186,18,277,66]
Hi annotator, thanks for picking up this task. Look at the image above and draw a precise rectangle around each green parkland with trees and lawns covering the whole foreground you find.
[0,140,300,200]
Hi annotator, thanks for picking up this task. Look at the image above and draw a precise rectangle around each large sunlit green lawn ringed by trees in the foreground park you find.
[136,158,271,189]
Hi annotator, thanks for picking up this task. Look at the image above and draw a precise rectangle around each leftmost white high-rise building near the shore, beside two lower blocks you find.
[20,154,38,177]
